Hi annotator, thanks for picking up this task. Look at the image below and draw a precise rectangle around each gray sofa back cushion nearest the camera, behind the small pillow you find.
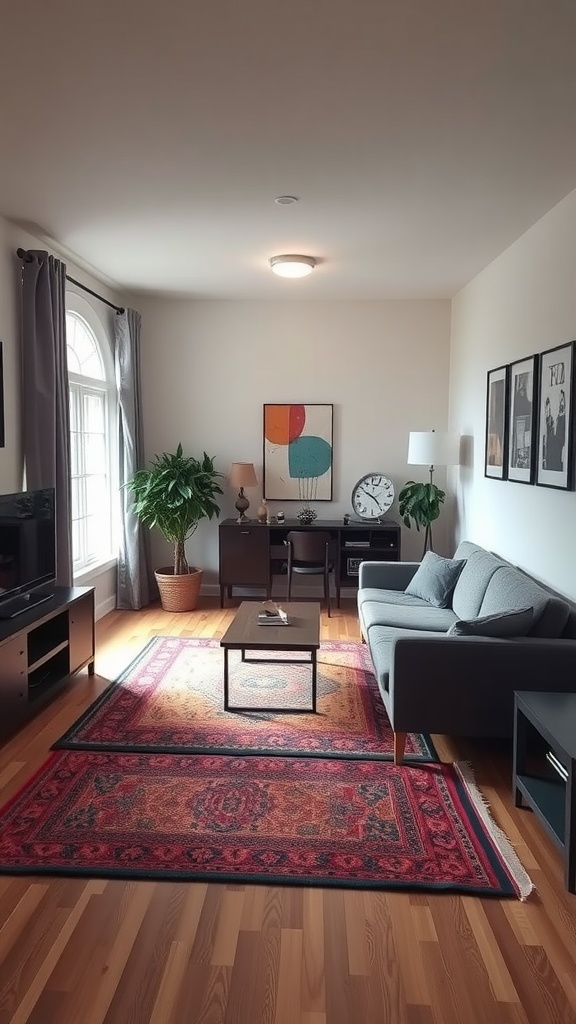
[480,565,570,638]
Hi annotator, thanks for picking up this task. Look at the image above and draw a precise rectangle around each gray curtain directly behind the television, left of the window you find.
[18,250,73,587]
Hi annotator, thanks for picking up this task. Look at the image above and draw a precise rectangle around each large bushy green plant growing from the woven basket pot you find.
[125,444,223,575]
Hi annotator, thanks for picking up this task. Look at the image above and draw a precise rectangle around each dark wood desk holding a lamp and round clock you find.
[218,519,401,607]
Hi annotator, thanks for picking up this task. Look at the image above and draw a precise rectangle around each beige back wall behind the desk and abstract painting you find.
[138,300,453,584]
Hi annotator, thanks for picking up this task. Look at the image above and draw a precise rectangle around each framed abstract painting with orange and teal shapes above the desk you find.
[262,402,334,504]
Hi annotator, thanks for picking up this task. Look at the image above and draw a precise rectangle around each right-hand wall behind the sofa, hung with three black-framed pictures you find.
[450,191,576,599]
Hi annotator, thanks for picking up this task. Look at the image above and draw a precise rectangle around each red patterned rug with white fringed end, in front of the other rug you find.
[0,751,531,898]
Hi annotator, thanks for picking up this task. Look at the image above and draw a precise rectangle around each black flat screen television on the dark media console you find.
[0,487,56,618]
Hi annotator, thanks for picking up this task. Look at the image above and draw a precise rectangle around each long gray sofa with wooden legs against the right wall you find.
[358,541,576,763]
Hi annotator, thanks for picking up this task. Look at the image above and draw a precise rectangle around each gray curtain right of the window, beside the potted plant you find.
[114,309,152,608]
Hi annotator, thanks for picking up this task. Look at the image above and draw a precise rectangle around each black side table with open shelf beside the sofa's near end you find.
[512,690,576,893]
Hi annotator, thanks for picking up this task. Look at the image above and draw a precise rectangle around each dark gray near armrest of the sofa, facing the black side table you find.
[386,636,576,736]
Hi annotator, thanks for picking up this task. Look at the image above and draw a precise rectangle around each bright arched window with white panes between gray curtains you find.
[66,295,117,577]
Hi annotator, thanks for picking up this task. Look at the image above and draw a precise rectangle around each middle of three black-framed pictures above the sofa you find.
[507,355,538,483]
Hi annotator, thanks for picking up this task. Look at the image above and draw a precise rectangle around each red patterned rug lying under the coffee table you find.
[54,637,438,761]
